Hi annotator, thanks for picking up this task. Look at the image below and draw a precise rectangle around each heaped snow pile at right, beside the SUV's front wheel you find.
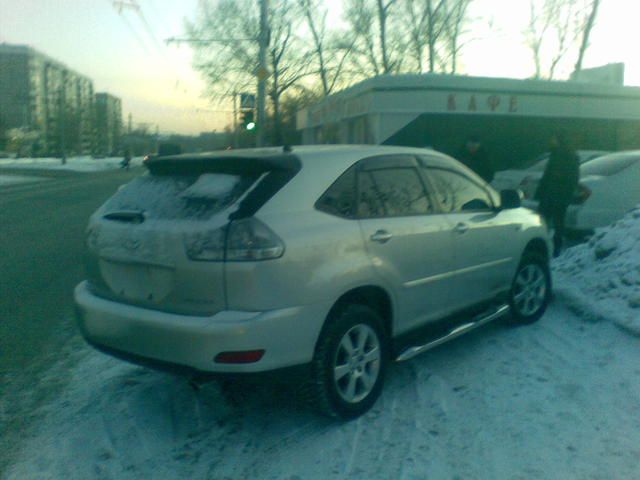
[553,205,640,336]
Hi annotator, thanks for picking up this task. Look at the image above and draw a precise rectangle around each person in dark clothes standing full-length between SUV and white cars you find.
[536,133,580,256]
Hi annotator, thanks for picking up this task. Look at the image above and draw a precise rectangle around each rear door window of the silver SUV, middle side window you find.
[358,168,433,218]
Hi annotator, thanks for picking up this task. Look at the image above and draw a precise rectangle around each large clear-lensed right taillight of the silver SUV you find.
[184,218,284,262]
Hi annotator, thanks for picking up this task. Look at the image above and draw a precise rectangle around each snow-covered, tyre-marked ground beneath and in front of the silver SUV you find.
[6,301,640,480]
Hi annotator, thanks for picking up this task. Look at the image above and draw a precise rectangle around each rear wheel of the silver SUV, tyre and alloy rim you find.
[307,304,389,419]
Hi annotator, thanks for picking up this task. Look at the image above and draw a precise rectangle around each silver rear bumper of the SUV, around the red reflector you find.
[74,282,328,373]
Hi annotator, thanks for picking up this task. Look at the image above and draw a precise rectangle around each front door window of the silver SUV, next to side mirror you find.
[426,168,492,213]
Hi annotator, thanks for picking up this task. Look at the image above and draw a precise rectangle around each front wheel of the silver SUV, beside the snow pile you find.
[509,252,551,324]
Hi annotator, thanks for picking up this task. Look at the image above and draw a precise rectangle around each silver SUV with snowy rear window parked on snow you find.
[75,146,551,418]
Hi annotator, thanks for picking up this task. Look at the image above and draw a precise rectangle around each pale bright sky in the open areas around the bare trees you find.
[0,0,640,134]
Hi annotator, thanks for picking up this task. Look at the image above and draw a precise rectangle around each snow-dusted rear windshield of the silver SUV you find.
[104,173,255,220]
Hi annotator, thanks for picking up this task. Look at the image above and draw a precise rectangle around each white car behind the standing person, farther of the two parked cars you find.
[491,150,609,199]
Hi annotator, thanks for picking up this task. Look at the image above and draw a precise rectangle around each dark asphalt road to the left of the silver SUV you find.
[0,169,141,470]
